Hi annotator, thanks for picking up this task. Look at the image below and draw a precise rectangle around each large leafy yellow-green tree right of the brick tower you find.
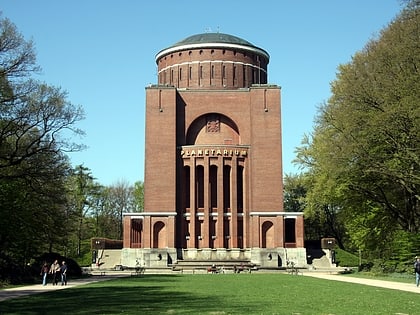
[298,1,420,260]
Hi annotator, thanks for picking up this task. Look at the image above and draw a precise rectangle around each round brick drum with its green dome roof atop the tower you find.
[156,33,270,89]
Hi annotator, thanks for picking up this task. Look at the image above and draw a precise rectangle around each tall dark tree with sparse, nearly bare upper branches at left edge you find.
[0,17,83,282]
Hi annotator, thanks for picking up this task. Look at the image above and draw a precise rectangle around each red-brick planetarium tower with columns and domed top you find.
[122,33,306,267]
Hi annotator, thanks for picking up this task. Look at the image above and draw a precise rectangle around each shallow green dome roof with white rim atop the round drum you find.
[156,33,270,61]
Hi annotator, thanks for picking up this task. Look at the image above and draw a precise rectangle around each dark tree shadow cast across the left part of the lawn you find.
[0,275,258,315]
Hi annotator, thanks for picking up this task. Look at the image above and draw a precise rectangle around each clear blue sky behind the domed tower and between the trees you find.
[0,0,401,185]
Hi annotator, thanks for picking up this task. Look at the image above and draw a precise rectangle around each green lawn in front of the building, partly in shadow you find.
[0,274,420,315]
